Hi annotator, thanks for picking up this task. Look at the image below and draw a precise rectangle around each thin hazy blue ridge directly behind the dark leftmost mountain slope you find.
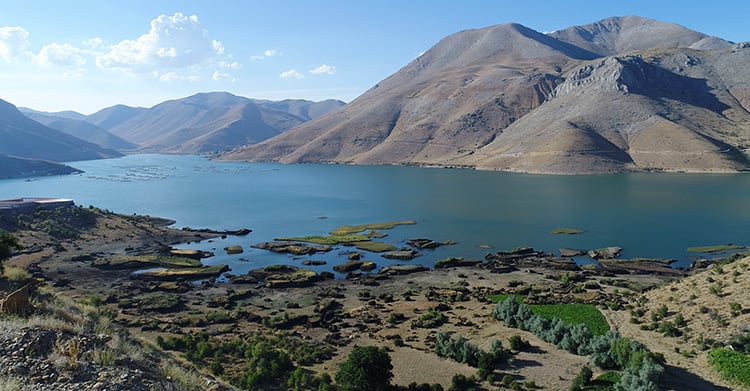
[25,112,137,151]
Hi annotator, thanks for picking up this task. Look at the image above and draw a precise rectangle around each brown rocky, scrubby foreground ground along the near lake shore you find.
[0,207,750,390]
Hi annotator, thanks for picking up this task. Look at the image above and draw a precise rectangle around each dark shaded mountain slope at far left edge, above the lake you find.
[0,100,122,162]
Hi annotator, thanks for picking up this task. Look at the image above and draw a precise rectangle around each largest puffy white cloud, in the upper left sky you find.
[96,12,225,72]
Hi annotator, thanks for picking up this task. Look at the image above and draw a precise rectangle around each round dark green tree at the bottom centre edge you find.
[336,346,393,391]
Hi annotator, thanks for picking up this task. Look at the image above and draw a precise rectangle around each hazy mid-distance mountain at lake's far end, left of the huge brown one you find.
[106,92,343,153]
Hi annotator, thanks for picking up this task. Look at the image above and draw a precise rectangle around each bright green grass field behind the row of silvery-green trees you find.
[488,294,609,335]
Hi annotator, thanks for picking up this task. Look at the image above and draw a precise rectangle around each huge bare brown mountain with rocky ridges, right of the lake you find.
[221,16,750,173]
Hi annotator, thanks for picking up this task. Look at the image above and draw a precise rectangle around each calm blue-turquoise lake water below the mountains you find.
[0,155,750,273]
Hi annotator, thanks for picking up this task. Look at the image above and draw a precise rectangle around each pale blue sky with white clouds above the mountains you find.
[0,0,750,114]
